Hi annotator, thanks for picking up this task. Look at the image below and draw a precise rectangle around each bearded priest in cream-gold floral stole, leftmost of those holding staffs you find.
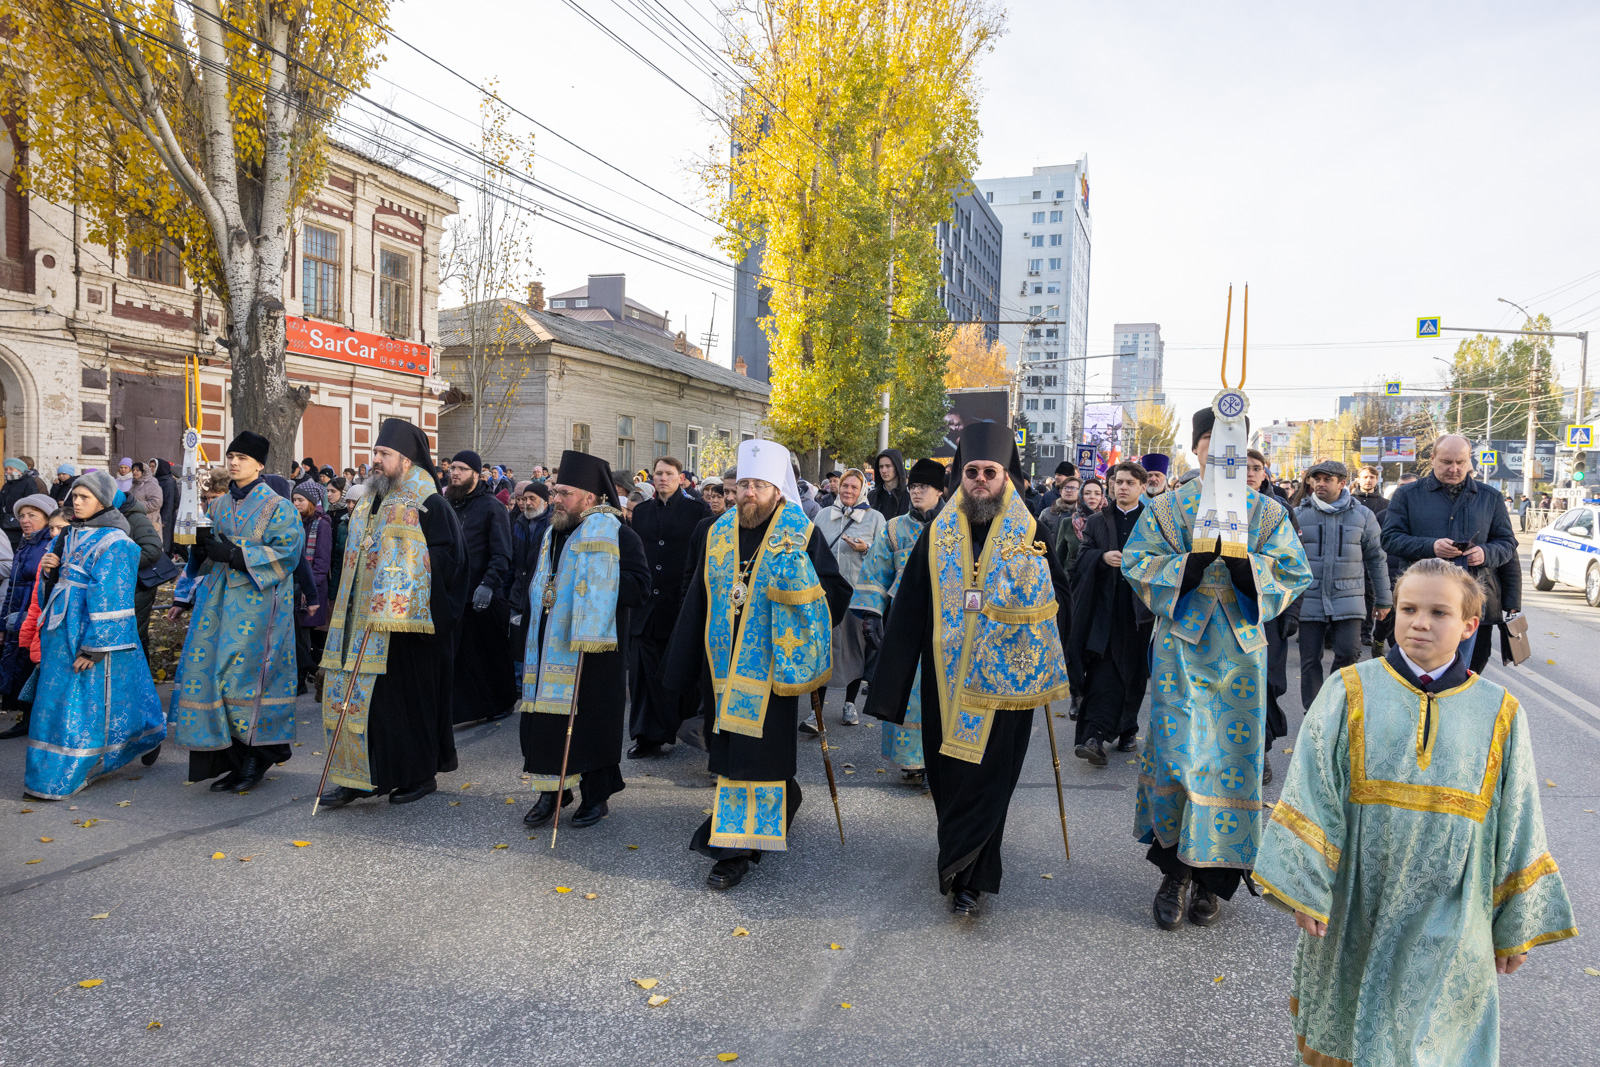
[322,419,470,808]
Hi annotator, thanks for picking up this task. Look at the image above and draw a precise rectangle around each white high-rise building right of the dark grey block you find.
[976,155,1091,474]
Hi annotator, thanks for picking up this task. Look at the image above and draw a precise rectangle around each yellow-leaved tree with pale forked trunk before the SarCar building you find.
[0,0,389,456]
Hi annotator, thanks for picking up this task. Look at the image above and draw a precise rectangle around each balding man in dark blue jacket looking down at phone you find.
[1384,434,1522,673]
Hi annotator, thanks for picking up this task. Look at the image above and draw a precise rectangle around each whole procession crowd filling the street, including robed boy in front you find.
[0,408,1576,1062]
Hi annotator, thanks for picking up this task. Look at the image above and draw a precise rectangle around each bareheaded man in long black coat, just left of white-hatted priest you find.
[627,456,710,760]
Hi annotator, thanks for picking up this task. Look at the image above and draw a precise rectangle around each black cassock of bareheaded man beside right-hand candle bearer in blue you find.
[1067,501,1155,744]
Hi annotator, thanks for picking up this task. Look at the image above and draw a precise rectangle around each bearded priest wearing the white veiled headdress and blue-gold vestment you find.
[666,440,851,889]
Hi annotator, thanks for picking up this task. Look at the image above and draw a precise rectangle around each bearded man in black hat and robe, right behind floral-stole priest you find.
[445,450,517,726]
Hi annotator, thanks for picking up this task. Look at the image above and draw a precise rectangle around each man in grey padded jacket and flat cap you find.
[1298,459,1394,707]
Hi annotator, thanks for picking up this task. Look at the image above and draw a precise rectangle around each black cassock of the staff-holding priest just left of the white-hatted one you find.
[518,523,650,805]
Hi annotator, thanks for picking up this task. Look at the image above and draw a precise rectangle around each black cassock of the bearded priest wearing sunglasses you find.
[867,511,1072,893]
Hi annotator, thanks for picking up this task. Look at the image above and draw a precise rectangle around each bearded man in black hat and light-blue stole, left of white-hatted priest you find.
[517,451,651,829]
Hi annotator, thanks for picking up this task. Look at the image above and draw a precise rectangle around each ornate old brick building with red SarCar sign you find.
[0,138,458,474]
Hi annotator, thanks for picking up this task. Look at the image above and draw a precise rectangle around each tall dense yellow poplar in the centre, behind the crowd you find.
[702,0,1003,470]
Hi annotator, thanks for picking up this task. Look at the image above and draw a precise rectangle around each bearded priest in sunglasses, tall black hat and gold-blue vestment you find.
[867,422,1072,917]
